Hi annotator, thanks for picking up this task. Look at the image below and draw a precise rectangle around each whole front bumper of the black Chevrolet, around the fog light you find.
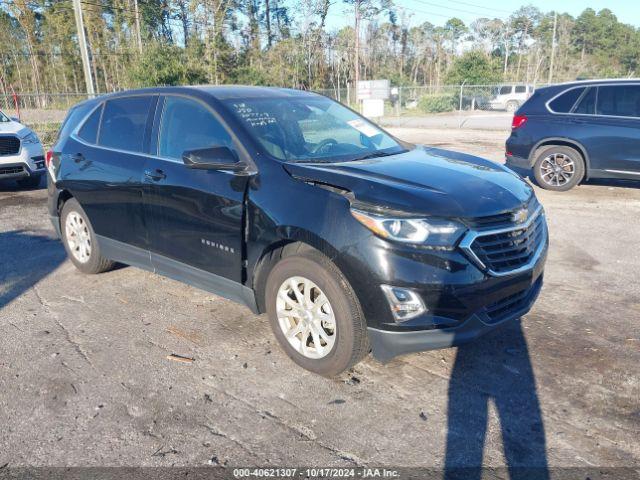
[341,207,549,362]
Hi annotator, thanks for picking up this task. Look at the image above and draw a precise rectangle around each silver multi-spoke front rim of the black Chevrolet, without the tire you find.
[276,276,337,359]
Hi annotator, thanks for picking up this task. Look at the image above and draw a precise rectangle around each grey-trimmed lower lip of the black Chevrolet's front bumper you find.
[368,270,542,363]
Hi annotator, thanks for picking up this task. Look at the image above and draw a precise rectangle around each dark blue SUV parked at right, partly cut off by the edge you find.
[506,80,640,191]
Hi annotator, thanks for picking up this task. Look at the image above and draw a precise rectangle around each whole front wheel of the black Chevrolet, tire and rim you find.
[265,249,369,377]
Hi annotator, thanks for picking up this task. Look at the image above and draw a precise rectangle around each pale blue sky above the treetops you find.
[327,0,640,29]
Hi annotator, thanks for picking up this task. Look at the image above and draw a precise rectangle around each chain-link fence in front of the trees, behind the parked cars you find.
[0,83,535,147]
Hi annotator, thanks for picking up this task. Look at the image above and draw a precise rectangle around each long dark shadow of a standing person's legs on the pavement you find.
[445,320,549,480]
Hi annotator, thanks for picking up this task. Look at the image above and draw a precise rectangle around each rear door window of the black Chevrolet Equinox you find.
[98,96,153,152]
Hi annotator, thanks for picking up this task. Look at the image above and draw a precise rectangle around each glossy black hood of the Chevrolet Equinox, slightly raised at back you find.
[285,146,533,218]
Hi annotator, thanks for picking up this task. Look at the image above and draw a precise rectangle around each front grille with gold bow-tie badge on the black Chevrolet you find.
[469,210,545,274]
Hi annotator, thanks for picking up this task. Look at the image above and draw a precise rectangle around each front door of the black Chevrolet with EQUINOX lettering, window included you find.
[144,95,247,283]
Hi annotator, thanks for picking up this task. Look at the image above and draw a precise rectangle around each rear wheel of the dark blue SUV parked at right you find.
[533,145,585,192]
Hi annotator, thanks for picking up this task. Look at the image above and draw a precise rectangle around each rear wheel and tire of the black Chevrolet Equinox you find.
[60,198,114,274]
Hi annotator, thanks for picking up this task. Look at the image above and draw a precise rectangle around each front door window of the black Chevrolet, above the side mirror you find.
[158,97,234,160]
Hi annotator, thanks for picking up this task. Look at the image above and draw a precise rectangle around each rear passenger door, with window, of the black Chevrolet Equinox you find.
[58,95,157,251]
